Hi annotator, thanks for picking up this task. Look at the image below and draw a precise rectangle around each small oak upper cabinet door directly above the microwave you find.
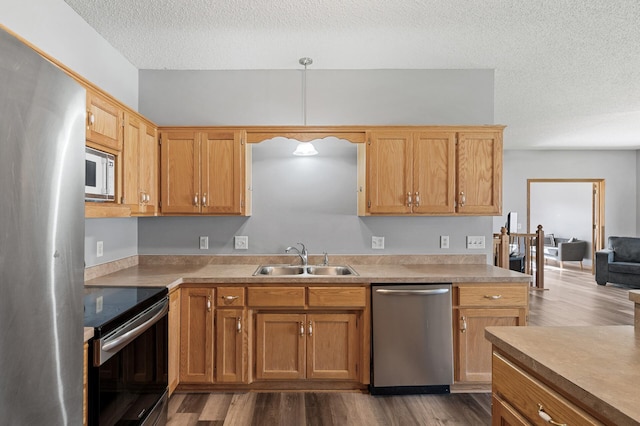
[86,89,124,152]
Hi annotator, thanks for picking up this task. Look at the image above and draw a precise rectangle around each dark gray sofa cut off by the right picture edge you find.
[596,237,640,288]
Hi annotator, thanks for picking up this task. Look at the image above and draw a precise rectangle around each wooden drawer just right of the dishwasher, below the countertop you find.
[458,284,529,307]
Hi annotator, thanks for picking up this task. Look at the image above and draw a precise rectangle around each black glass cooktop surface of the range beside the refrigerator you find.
[84,286,168,337]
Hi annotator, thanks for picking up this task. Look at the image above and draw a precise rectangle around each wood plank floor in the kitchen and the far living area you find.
[168,264,633,426]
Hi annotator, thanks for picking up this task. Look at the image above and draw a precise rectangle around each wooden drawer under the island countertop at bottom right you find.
[493,353,602,425]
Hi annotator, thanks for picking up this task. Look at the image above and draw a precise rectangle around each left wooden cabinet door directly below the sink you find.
[256,313,306,380]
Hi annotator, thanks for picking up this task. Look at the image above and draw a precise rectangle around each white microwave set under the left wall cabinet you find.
[84,147,115,201]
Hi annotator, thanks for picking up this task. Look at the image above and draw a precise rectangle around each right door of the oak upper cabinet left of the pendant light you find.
[200,131,244,215]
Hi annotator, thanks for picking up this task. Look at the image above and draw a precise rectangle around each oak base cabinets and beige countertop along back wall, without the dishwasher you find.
[85,255,531,392]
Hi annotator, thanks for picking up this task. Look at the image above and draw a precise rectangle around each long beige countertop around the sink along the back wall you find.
[85,256,532,289]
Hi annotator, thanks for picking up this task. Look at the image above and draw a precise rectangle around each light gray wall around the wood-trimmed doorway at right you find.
[493,150,638,241]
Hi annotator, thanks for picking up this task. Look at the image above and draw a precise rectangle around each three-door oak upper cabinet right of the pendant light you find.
[358,126,502,215]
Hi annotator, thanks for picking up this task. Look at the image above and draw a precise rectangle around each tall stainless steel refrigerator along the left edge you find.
[0,28,86,425]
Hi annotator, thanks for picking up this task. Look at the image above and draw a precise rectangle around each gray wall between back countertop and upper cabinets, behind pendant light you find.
[139,138,491,254]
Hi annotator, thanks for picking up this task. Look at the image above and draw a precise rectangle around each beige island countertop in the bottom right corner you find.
[485,325,640,425]
